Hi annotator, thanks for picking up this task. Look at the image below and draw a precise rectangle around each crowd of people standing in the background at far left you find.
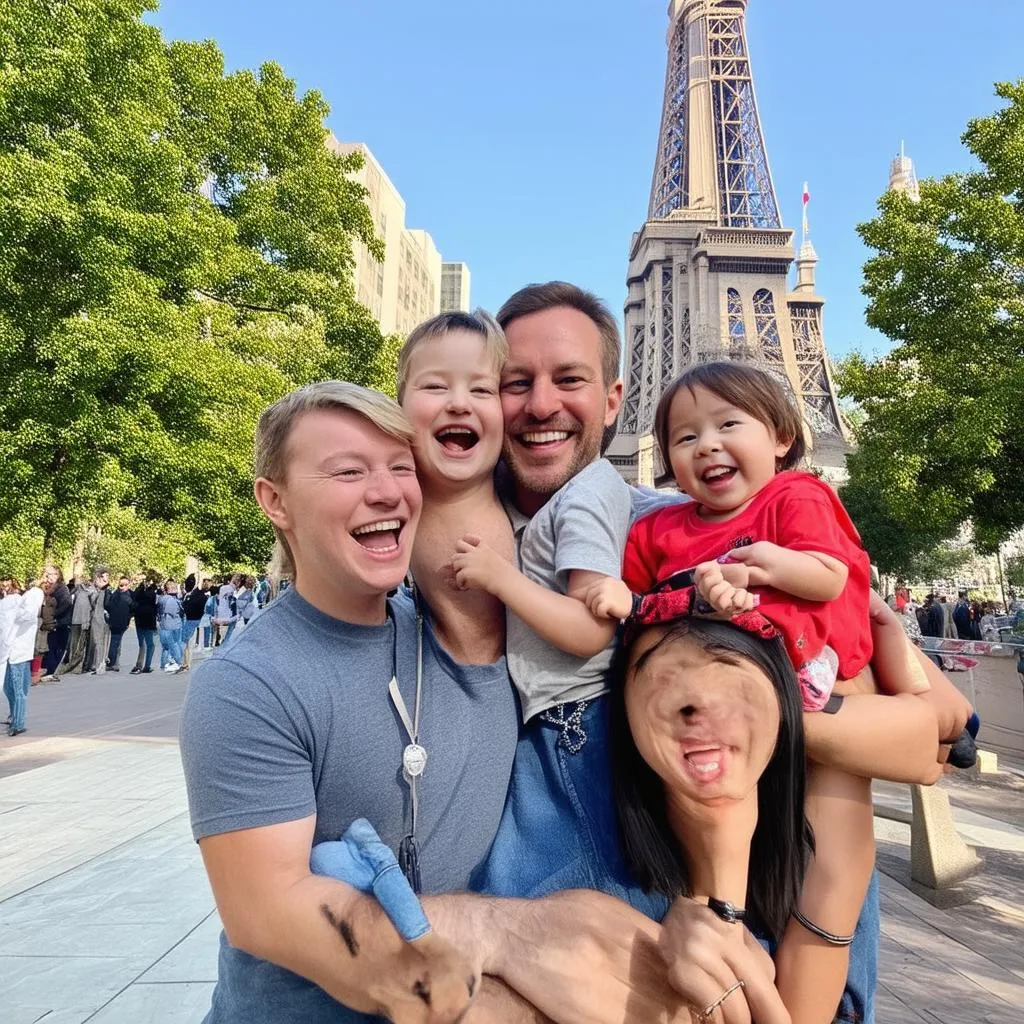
[0,565,271,736]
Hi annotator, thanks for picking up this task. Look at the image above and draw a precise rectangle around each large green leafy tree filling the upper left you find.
[0,0,394,561]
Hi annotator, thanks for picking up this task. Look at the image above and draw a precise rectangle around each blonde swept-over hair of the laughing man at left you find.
[253,381,414,580]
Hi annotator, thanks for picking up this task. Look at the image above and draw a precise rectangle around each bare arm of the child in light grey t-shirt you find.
[452,537,617,657]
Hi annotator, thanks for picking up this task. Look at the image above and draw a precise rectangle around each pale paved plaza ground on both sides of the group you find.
[6,643,1024,1024]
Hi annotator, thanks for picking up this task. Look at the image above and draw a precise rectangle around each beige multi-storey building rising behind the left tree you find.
[328,135,441,335]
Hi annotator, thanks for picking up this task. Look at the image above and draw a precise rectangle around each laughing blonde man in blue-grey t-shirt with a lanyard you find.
[181,381,521,1024]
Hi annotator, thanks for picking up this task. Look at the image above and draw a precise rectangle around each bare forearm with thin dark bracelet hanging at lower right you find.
[775,765,874,1024]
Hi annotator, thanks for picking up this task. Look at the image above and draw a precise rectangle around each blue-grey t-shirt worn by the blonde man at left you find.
[181,589,517,1024]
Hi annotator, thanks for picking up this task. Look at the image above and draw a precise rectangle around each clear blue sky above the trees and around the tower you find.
[154,0,1024,355]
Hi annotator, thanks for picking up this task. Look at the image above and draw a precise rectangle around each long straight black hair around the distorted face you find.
[609,618,814,940]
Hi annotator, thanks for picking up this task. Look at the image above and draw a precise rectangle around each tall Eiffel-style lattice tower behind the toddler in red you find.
[608,0,849,480]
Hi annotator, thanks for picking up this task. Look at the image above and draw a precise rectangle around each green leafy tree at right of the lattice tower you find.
[842,81,1024,554]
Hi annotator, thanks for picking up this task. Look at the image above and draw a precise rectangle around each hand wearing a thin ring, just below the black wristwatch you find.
[660,897,791,1024]
